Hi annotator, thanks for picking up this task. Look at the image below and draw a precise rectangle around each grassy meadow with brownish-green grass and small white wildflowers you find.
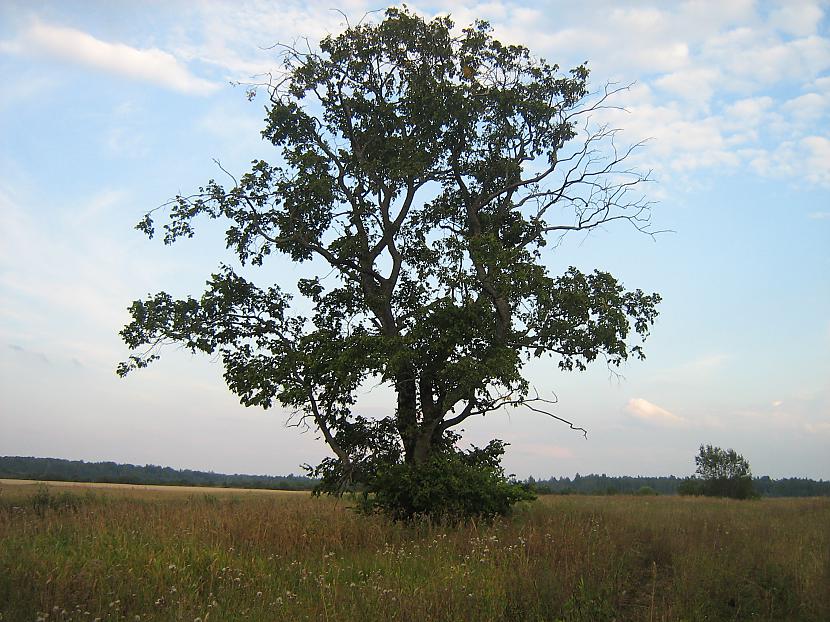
[0,482,830,622]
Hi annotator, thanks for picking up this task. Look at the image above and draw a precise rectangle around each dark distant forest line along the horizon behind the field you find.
[0,456,830,497]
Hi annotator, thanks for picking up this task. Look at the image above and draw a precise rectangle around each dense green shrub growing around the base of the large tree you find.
[358,441,536,522]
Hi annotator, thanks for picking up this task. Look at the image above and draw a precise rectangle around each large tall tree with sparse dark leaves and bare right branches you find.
[118,8,660,520]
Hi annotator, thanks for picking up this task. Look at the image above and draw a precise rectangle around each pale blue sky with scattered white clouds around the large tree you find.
[0,0,830,479]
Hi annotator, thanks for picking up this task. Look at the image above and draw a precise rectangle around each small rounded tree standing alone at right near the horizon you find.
[678,445,754,499]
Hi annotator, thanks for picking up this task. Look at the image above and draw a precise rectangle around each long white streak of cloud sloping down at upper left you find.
[0,21,219,95]
